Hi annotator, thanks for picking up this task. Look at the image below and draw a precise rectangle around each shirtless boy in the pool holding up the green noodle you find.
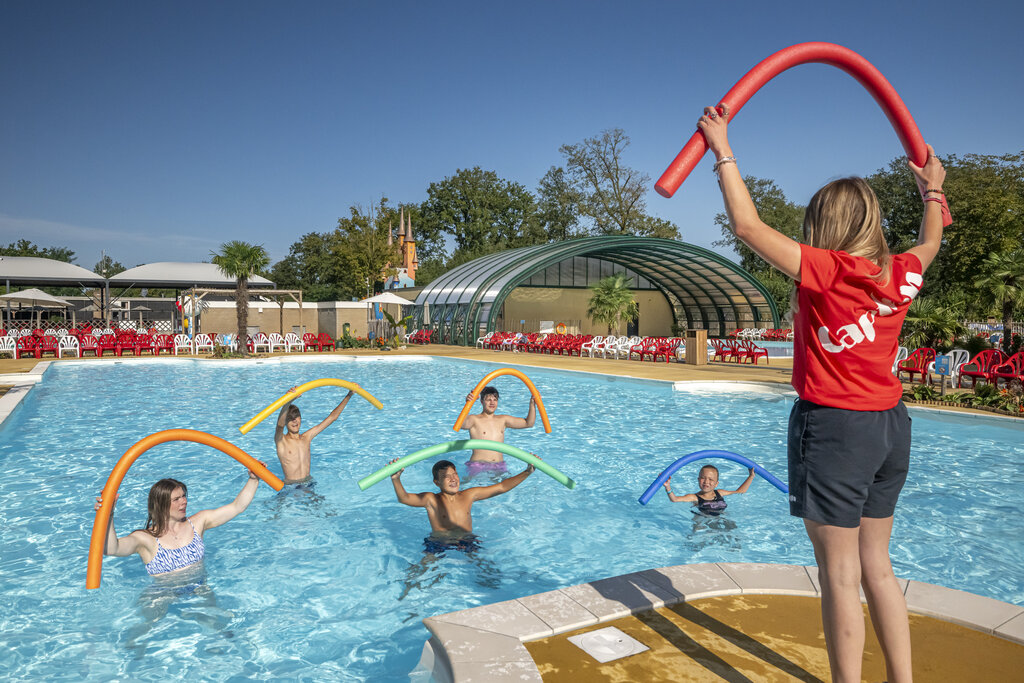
[391,458,534,542]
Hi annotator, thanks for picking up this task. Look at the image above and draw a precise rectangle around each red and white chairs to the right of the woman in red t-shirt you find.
[893,346,1024,389]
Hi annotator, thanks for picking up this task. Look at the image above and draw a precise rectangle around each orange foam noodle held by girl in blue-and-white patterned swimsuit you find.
[85,429,285,588]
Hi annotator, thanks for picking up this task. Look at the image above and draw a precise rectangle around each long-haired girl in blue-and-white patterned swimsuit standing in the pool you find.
[94,471,259,575]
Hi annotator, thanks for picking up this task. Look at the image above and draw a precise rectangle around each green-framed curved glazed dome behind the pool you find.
[413,236,780,346]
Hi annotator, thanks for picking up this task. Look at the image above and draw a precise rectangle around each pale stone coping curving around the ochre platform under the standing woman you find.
[421,562,1024,683]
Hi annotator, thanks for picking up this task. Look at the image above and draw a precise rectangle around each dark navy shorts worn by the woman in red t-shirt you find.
[788,398,910,528]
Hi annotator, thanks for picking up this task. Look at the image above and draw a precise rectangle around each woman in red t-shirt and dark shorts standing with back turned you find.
[697,104,946,683]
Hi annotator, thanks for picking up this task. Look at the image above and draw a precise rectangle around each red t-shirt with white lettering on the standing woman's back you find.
[793,245,923,411]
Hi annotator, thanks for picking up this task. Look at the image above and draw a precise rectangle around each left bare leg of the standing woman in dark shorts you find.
[804,519,864,683]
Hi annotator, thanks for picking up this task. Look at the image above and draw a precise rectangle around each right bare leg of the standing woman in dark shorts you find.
[860,517,913,683]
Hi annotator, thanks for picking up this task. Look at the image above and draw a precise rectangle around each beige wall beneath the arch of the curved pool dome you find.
[504,287,672,337]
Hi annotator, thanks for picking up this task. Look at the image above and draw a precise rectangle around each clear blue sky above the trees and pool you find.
[0,0,1024,268]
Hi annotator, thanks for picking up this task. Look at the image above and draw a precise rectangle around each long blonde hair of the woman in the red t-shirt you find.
[804,177,890,281]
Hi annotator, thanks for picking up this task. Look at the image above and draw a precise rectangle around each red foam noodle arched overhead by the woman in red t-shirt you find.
[654,43,953,226]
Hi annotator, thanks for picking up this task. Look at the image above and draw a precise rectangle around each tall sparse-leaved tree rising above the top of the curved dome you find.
[559,128,679,239]
